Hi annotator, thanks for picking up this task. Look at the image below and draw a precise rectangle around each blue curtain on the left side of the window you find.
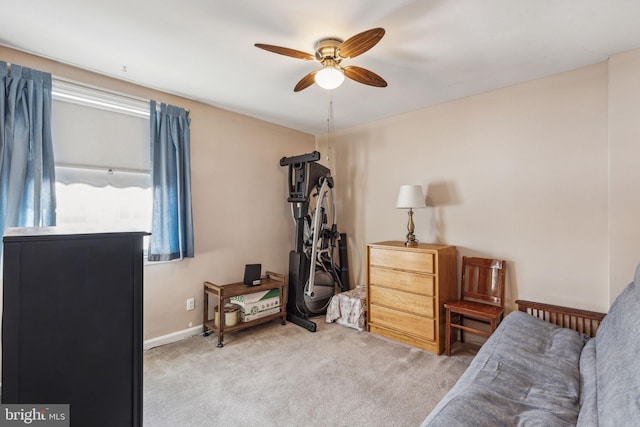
[0,62,56,246]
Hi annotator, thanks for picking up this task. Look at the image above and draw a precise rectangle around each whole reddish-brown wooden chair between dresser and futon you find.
[444,256,507,356]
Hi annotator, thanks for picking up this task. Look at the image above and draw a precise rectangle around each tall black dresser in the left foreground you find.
[2,227,148,426]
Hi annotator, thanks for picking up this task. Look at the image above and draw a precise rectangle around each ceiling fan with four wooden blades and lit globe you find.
[255,28,387,92]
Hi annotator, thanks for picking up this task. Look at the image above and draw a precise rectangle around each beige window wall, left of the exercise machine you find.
[0,47,315,340]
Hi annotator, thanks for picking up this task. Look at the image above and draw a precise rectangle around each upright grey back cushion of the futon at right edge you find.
[595,265,640,426]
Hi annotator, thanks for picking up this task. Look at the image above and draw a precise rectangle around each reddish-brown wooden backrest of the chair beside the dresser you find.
[461,256,507,307]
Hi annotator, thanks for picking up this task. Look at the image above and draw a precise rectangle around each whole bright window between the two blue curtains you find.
[51,79,152,247]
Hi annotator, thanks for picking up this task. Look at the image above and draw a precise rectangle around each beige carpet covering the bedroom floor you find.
[143,317,475,427]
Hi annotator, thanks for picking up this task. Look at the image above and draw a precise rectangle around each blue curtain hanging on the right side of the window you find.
[148,101,193,261]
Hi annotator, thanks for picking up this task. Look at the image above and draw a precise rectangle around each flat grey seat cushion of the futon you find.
[422,311,584,427]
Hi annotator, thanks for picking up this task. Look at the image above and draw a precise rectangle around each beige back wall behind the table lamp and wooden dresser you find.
[318,63,616,311]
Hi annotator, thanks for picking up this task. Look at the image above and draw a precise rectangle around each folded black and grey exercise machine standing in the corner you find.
[280,151,349,332]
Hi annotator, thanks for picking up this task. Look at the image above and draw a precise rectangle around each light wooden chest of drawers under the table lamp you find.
[367,241,457,354]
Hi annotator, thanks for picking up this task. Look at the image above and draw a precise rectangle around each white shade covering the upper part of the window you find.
[51,79,151,188]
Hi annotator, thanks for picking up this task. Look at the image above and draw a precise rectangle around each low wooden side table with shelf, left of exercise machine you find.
[202,271,287,347]
